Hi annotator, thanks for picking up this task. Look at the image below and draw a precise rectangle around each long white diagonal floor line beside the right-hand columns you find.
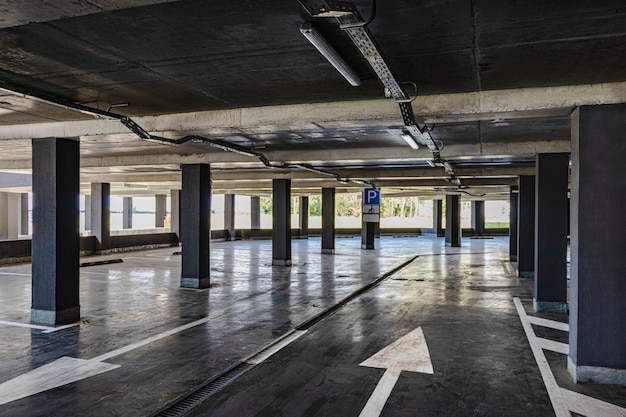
[513,297,572,417]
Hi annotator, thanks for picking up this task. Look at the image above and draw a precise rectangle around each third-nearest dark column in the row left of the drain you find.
[272,179,291,266]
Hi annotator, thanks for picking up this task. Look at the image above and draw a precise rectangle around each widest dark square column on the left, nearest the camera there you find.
[31,139,80,325]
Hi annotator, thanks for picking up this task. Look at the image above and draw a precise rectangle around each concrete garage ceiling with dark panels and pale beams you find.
[0,0,626,198]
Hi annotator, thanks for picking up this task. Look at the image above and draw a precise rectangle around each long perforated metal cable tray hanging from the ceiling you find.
[299,0,460,184]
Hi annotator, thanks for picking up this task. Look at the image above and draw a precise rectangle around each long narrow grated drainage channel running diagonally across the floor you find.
[152,255,418,417]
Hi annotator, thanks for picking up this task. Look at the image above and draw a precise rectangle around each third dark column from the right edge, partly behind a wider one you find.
[517,175,535,278]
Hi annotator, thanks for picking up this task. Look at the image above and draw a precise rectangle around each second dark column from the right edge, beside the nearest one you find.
[534,153,569,313]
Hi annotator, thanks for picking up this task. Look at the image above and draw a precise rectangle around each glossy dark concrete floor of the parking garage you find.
[0,237,626,417]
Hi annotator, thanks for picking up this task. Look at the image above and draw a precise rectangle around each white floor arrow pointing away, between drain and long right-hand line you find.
[359,327,433,417]
